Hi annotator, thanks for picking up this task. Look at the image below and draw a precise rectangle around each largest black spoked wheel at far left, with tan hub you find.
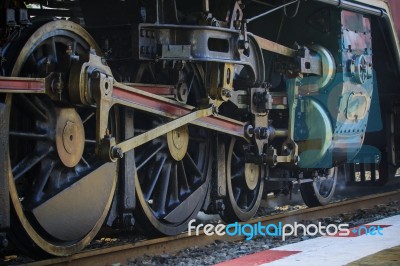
[5,21,117,257]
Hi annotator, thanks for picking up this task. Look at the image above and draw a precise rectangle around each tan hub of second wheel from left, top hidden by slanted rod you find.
[167,125,189,161]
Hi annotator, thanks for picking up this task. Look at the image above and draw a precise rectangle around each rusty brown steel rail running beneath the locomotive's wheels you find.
[22,190,400,266]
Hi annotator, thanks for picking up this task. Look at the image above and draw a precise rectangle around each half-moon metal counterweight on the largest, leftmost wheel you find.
[32,163,116,241]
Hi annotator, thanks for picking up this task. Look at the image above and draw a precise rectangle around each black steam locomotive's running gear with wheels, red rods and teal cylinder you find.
[0,0,400,256]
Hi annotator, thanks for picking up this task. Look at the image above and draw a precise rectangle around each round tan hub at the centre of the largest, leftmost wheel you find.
[55,108,85,167]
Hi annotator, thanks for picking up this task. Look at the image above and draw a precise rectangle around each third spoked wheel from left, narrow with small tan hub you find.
[220,138,264,223]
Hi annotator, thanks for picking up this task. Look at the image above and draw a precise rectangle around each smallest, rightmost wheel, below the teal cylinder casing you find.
[300,167,338,207]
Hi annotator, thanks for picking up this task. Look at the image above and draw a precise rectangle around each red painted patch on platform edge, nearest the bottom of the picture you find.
[215,250,301,266]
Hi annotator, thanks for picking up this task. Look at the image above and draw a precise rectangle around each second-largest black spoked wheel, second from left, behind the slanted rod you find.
[134,65,210,235]
